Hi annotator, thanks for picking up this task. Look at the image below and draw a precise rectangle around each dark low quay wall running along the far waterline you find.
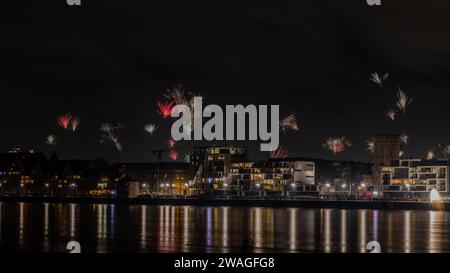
[0,196,450,211]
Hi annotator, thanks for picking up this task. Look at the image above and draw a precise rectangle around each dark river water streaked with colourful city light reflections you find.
[0,203,450,253]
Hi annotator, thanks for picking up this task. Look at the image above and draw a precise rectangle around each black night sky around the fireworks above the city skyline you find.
[0,0,450,161]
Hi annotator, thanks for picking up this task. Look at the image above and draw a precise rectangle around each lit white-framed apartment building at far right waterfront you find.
[380,159,449,199]
